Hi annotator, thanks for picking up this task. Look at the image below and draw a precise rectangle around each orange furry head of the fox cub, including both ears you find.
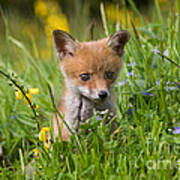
[53,30,130,101]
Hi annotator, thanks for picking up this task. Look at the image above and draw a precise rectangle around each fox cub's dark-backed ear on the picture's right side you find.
[107,30,130,56]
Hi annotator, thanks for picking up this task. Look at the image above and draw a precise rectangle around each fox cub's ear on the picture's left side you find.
[53,30,80,60]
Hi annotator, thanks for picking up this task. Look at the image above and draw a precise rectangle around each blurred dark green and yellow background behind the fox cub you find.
[0,0,176,66]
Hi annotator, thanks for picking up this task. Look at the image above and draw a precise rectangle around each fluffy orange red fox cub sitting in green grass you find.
[53,30,130,140]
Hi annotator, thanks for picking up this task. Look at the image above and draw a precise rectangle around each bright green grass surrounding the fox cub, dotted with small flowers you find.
[0,1,180,180]
